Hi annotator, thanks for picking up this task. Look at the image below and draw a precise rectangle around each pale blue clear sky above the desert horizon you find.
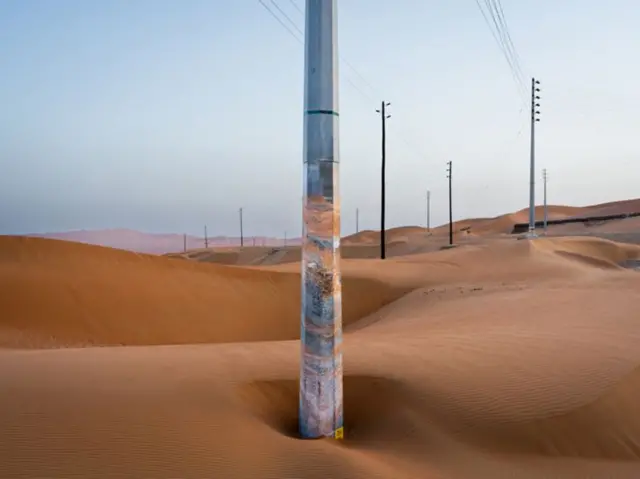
[0,0,640,236]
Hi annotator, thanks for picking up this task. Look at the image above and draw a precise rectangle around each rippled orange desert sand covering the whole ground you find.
[0,202,640,479]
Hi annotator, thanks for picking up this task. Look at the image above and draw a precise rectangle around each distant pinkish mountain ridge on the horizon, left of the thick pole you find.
[29,229,300,254]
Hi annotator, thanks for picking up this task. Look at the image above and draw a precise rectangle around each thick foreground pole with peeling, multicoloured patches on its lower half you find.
[299,0,344,438]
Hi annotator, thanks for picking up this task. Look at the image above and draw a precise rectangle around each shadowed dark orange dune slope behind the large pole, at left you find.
[0,237,405,347]
